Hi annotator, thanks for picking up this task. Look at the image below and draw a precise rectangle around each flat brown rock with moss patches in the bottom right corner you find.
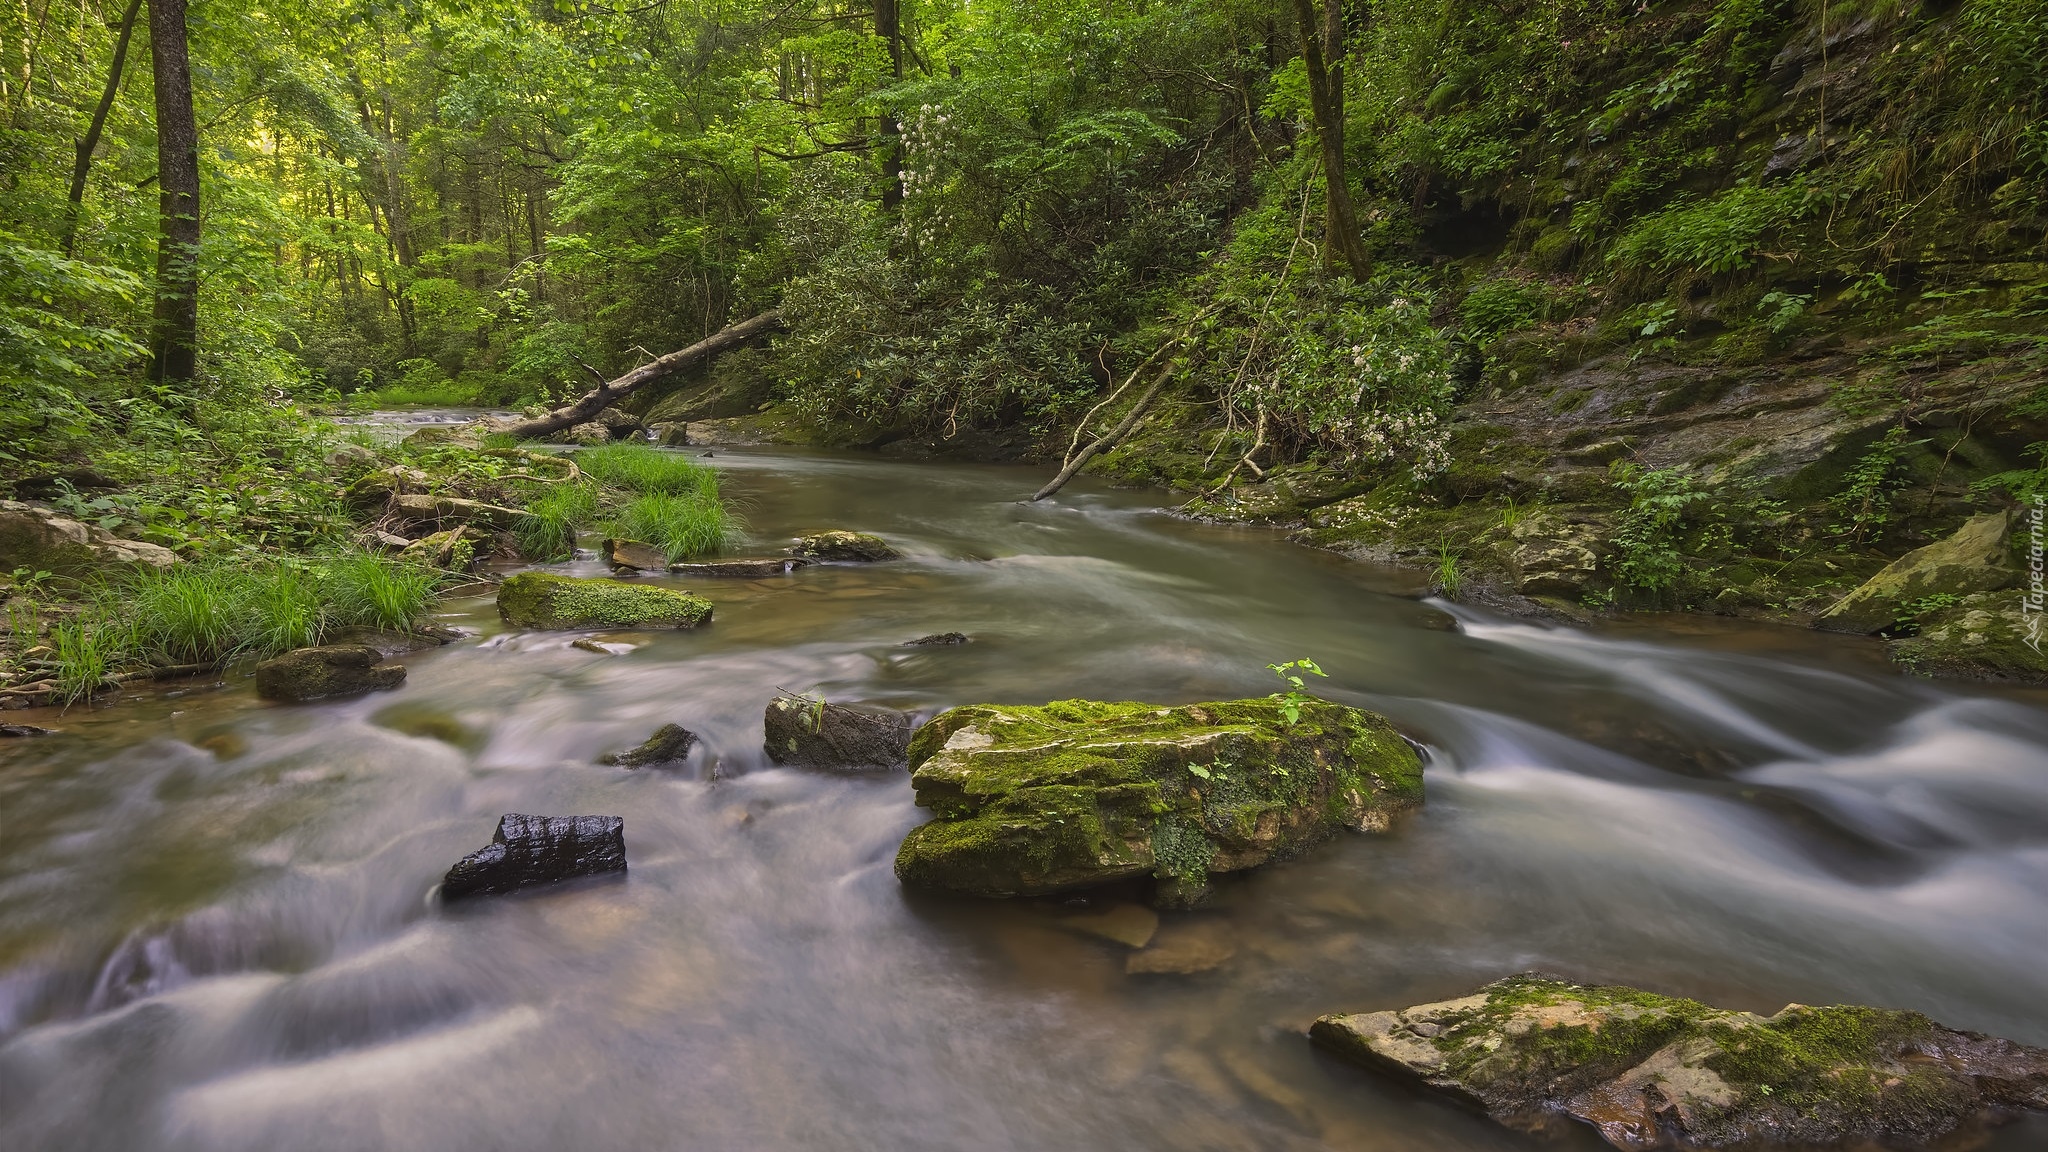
[1309,974,2048,1150]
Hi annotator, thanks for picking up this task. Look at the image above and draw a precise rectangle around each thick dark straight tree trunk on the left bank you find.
[150,0,199,383]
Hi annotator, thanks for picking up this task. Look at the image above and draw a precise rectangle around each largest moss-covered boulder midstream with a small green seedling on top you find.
[895,699,1421,906]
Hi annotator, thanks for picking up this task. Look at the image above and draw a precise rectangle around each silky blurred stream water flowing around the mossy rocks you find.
[0,451,2048,1152]
